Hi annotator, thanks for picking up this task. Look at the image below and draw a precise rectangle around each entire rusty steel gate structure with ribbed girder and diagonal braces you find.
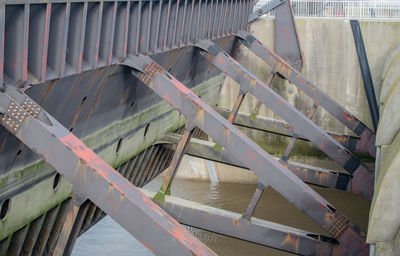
[0,0,375,255]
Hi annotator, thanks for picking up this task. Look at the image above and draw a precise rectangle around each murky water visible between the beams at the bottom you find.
[72,173,369,256]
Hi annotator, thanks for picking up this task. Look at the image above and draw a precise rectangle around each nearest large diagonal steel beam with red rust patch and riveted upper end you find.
[0,86,215,255]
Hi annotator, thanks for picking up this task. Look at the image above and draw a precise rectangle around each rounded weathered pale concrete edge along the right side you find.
[367,35,400,256]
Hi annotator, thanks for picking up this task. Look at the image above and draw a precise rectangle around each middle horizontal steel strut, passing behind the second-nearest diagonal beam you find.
[158,133,351,190]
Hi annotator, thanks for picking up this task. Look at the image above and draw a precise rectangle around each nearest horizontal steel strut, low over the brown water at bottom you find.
[141,189,337,255]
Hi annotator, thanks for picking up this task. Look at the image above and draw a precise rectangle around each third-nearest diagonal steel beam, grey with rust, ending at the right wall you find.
[195,40,374,200]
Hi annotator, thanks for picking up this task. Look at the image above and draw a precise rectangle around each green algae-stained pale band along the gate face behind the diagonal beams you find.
[0,75,225,240]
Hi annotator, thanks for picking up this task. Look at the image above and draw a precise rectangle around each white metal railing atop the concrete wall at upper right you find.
[255,0,400,20]
